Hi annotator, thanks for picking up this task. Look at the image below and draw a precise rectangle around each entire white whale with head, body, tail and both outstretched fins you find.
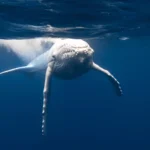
[0,39,122,134]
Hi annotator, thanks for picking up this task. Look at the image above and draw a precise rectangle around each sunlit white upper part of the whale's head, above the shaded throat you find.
[53,39,94,64]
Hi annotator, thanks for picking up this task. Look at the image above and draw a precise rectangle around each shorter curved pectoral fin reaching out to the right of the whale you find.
[92,62,123,96]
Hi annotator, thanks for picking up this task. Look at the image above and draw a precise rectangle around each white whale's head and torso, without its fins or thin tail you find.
[27,39,94,79]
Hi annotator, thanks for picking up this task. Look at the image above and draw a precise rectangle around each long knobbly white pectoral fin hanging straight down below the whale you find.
[42,64,53,135]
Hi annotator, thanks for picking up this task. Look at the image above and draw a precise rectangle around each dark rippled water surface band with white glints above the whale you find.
[0,0,150,39]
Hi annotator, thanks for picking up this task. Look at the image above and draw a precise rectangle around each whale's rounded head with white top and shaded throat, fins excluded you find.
[52,39,94,79]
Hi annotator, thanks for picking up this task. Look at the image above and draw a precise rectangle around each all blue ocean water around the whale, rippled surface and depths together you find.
[0,0,150,150]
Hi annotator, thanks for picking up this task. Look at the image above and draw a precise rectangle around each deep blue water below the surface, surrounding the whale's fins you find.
[0,38,150,150]
